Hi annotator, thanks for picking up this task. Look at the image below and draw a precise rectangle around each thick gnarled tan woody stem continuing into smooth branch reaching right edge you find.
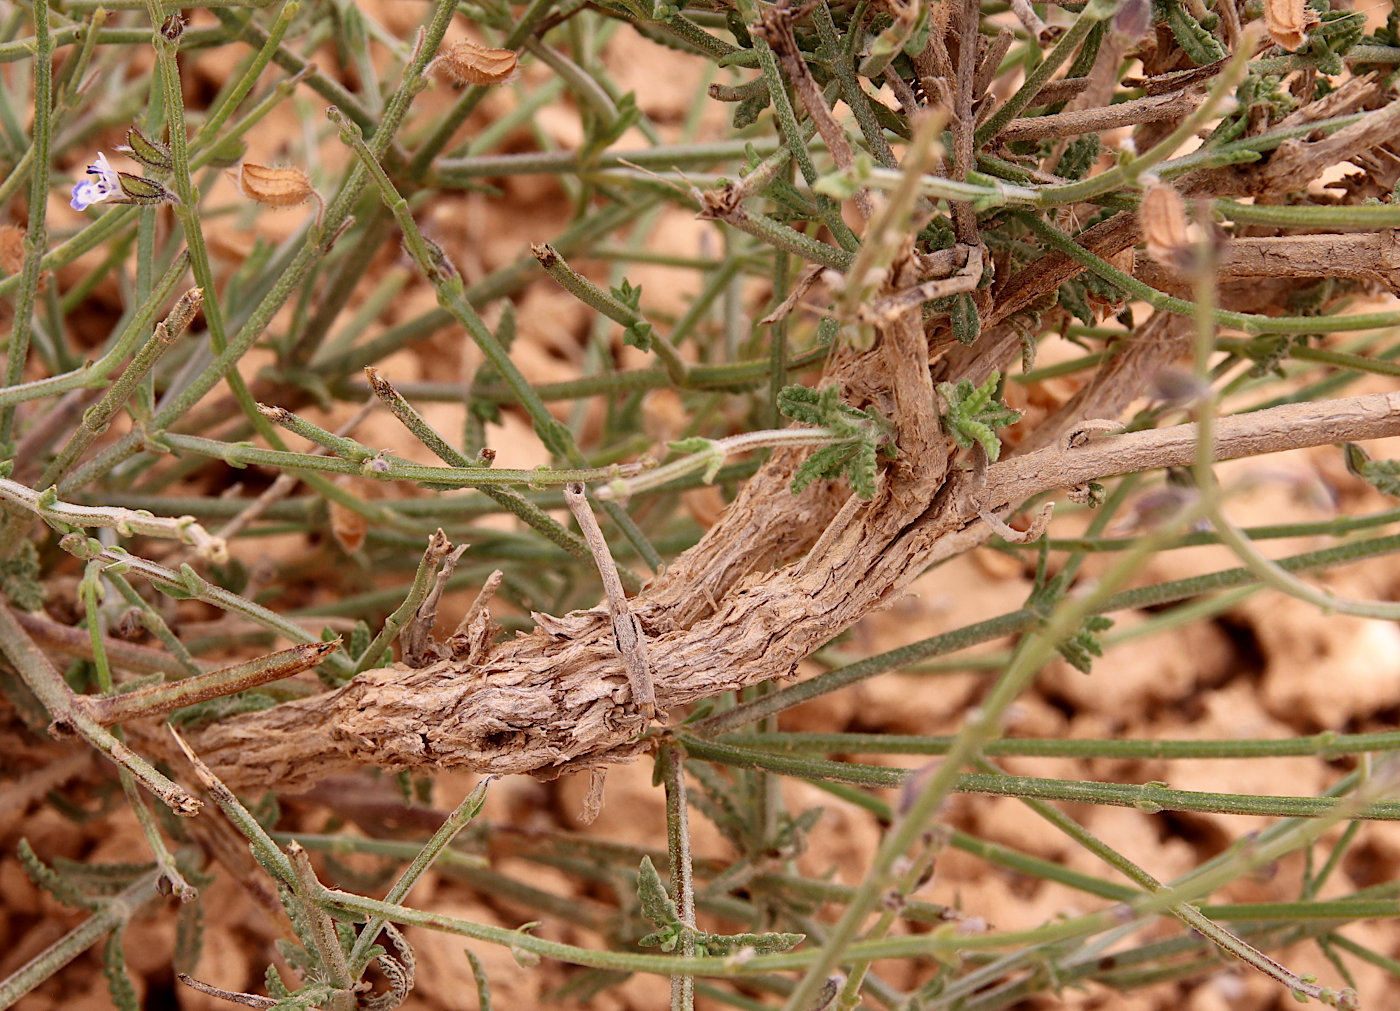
[196,393,1400,788]
